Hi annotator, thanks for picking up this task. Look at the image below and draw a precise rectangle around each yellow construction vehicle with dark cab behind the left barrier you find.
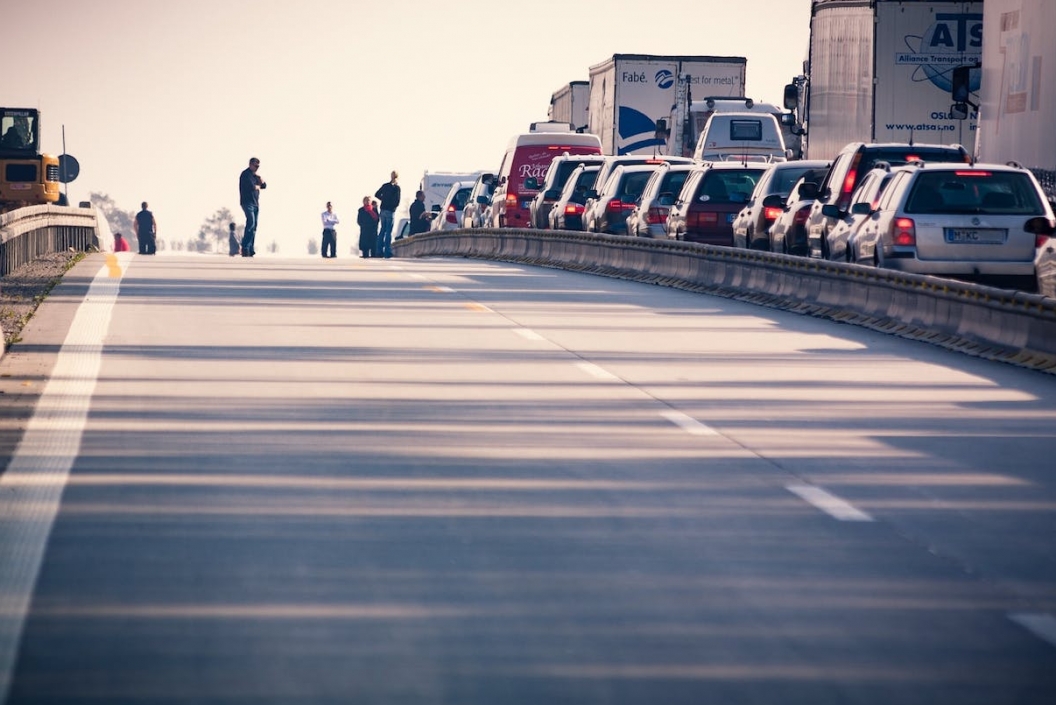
[0,108,59,212]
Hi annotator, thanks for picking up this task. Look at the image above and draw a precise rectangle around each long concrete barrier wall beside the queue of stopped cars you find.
[394,229,1056,374]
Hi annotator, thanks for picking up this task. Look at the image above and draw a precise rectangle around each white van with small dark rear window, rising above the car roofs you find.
[693,112,788,161]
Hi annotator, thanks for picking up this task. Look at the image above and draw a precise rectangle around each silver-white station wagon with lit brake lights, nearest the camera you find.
[859,163,1053,288]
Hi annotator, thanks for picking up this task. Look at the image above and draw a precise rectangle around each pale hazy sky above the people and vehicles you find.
[6,0,810,255]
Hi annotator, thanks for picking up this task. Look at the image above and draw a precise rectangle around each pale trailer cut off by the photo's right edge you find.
[977,0,1056,179]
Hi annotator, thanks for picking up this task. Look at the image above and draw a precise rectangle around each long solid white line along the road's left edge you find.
[0,252,131,703]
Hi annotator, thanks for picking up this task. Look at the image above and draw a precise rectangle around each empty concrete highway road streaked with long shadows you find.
[0,254,1056,705]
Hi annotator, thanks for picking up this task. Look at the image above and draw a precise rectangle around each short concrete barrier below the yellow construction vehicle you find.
[0,206,104,275]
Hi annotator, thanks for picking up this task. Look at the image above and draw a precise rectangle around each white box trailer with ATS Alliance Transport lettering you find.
[802,0,989,159]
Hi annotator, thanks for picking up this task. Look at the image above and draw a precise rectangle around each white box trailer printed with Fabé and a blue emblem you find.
[588,54,748,155]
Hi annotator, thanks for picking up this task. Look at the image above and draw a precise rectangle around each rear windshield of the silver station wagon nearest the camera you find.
[905,169,1044,215]
